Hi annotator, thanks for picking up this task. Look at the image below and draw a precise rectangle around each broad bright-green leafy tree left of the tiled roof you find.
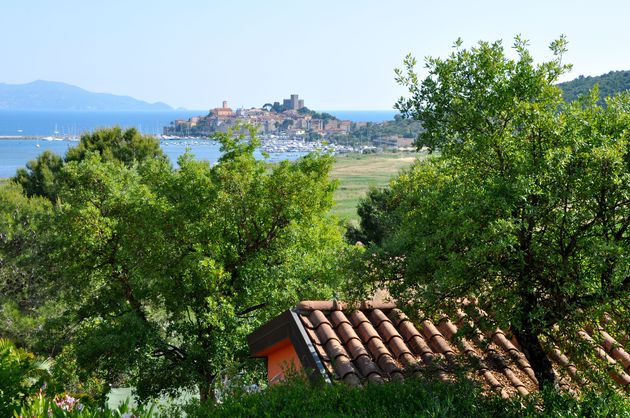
[39,126,344,400]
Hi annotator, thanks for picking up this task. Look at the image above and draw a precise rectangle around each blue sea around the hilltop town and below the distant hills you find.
[0,110,397,178]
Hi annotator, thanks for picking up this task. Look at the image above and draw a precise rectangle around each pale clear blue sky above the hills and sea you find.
[0,0,630,110]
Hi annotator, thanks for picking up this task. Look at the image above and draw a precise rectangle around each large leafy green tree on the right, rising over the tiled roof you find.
[360,38,630,386]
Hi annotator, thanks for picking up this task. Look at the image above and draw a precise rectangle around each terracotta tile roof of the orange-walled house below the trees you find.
[294,301,630,397]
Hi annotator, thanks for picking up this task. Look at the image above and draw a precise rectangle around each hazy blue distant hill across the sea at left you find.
[0,80,172,111]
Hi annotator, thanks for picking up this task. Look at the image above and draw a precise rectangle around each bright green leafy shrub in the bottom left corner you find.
[0,339,49,417]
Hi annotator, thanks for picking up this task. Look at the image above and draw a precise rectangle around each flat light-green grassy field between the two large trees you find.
[331,152,421,220]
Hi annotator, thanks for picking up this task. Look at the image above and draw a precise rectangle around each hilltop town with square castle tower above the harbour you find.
[164,94,365,139]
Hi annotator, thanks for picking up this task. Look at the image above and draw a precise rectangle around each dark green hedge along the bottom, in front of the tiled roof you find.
[184,379,629,417]
